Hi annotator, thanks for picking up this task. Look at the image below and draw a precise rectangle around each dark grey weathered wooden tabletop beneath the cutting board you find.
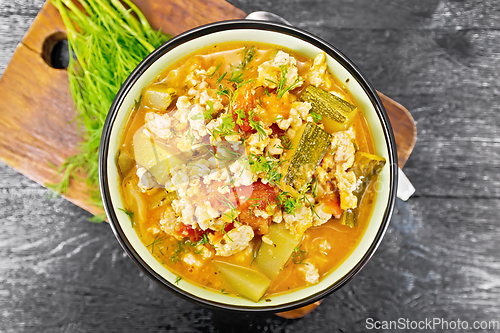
[0,0,500,332]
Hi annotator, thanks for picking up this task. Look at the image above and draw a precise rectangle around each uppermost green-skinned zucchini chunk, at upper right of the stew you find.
[300,85,357,133]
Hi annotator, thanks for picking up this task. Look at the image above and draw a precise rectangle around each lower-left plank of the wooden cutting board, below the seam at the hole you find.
[0,44,102,214]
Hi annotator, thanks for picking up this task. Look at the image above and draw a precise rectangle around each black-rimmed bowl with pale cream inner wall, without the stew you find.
[99,20,398,312]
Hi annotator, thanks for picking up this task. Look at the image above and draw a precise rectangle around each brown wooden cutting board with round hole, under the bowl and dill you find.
[0,0,416,214]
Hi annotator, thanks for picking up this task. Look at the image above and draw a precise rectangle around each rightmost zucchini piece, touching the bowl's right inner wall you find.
[340,151,386,227]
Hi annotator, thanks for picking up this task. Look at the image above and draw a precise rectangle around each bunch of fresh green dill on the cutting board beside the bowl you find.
[49,0,170,213]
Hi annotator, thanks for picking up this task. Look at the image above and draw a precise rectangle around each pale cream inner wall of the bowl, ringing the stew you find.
[106,29,391,307]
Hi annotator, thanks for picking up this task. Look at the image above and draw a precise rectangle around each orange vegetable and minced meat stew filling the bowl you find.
[117,42,385,302]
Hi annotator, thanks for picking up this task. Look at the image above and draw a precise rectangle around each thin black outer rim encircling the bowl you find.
[98,20,398,312]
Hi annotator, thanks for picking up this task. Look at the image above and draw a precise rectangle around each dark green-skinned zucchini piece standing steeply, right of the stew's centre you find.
[282,122,332,191]
